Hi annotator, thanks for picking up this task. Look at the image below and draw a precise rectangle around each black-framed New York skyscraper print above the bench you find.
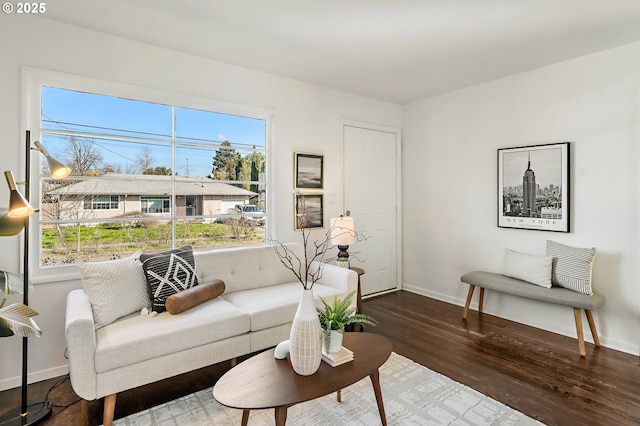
[498,142,570,232]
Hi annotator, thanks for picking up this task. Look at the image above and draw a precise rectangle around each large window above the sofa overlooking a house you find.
[29,70,271,268]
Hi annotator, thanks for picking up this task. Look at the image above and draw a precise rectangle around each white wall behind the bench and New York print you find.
[402,43,640,354]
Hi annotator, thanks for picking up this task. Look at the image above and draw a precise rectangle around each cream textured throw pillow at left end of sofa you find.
[78,252,151,329]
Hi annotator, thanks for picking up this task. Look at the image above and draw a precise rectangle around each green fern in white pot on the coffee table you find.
[316,291,378,353]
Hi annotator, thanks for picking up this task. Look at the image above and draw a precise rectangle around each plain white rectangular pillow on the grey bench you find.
[502,249,553,288]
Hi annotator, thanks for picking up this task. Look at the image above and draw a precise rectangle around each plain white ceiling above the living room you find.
[45,0,640,104]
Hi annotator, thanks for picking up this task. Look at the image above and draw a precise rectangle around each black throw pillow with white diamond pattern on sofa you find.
[140,246,198,313]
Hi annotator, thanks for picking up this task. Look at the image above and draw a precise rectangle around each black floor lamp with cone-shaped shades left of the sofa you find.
[0,130,71,426]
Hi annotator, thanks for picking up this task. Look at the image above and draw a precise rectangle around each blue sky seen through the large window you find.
[42,87,266,176]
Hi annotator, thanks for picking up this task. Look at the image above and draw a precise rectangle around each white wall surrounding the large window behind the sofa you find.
[0,14,402,390]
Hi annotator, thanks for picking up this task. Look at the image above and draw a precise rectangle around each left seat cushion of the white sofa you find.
[95,297,250,373]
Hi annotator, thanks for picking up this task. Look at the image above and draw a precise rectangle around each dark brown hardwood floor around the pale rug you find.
[0,291,640,426]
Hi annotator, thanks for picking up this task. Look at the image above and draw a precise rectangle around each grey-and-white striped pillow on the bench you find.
[547,240,596,295]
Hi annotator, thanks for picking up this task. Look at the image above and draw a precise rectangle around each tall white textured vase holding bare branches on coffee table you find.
[289,289,322,376]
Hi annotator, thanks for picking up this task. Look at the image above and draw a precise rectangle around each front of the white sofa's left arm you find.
[65,289,97,400]
